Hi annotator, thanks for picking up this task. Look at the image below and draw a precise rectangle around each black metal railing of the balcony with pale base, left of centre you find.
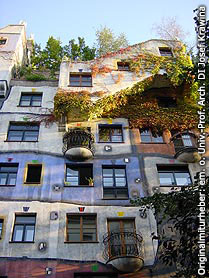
[62,129,94,154]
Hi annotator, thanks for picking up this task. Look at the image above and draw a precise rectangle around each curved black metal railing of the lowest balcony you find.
[103,231,143,262]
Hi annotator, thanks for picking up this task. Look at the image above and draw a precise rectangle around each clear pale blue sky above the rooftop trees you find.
[0,0,209,48]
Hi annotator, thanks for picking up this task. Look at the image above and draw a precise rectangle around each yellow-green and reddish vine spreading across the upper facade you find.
[54,48,199,131]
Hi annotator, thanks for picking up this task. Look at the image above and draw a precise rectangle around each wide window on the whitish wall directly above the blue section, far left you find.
[7,123,39,142]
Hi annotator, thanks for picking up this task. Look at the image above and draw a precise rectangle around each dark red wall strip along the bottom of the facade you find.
[0,259,151,278]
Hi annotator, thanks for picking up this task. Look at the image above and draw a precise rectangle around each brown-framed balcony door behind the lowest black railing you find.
[108,219,137,257]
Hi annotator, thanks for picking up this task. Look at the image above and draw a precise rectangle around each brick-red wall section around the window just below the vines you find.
[131,129,175,156]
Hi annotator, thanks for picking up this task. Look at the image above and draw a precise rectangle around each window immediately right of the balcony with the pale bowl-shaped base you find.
[99,125,123,143]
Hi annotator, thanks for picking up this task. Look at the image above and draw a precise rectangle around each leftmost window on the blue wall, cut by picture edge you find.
[0,163,18,186]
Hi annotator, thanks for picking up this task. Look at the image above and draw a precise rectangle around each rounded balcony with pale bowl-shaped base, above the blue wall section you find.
[62,129,94,161]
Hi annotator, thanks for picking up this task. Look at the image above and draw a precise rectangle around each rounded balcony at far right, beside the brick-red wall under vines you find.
[171,132,201,163]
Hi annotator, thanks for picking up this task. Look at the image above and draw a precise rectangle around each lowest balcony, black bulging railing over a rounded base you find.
[103,231,144,272]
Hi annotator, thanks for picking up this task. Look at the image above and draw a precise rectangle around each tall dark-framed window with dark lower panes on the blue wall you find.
[102,166,128,199]
